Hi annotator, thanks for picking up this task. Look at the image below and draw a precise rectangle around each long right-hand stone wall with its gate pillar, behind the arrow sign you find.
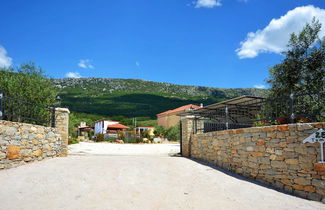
[182,119,325,201]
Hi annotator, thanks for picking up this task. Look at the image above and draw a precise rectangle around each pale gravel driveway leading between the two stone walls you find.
[0,144,325,210]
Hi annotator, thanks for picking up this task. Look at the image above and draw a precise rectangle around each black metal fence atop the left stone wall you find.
[0,91,55,127]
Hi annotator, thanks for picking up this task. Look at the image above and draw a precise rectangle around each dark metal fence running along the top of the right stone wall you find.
[193,91,325,133]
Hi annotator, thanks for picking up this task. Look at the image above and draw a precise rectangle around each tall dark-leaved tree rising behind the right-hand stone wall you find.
[267,18,325,98]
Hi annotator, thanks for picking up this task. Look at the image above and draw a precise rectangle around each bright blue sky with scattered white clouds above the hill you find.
[0,0,325,88]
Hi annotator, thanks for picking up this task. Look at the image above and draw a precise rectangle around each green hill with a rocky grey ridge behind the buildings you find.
[54,78,267,118]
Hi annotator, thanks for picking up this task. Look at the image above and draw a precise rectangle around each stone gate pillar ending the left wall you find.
[55,108,70,157]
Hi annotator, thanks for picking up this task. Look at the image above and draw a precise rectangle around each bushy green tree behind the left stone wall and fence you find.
[0,63,57,123]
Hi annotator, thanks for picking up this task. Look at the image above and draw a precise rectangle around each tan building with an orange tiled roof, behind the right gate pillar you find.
[157,104,201,128]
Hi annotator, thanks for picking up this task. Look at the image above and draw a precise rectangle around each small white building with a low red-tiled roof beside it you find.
[95,120,129,137]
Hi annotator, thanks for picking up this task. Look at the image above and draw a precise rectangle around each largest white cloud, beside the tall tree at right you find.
[236,5,325,59]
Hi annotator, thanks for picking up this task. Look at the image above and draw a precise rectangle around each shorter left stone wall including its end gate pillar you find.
[0,108,69,169]
